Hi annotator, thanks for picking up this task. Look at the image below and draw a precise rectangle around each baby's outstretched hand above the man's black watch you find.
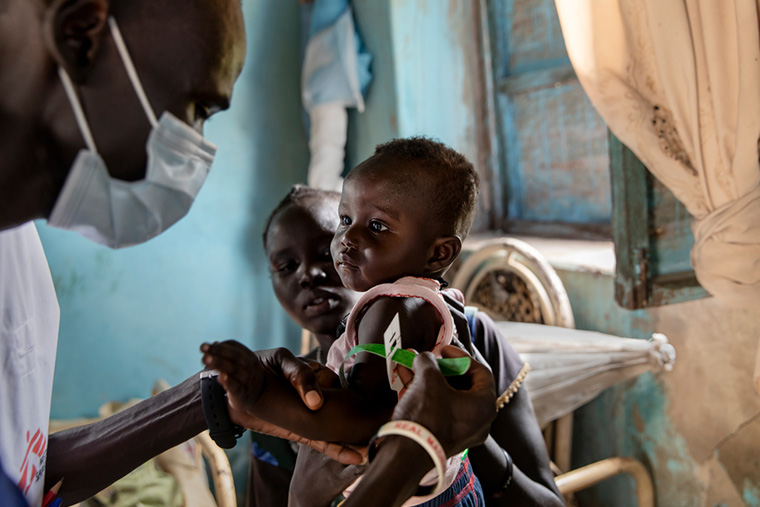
[201,340,266,412]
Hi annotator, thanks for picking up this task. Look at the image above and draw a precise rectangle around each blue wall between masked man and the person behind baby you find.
[38,0,308,418]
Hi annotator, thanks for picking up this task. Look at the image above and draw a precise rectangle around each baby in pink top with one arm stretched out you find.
[207,138,483,506]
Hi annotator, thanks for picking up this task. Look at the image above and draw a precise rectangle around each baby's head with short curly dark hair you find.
[331,137,478,291]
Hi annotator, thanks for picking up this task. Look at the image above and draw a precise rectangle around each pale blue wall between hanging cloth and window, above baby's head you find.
[347,0,484,183]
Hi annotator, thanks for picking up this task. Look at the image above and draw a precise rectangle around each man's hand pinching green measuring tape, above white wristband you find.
[392,345,496,456]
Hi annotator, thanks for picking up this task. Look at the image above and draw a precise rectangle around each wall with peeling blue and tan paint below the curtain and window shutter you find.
[559,270,760,507]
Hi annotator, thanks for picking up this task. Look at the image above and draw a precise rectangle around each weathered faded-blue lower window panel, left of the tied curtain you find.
[500,81,612,223]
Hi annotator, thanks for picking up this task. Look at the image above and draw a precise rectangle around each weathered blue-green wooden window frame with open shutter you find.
[480,0,709,310]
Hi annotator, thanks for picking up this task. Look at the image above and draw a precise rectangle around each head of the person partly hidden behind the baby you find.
[264,185,356,335]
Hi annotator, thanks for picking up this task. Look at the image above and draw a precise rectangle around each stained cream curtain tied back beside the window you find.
[556,0,760,392]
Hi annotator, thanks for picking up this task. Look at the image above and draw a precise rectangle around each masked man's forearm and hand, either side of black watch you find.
[45,350,354,505]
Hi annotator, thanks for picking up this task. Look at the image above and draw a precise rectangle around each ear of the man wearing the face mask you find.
[42,0,109,83]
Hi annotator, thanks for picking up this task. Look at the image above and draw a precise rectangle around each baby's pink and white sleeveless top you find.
[327,276,464,507]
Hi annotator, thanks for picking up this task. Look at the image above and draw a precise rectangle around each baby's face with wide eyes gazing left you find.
[331,172,433,292]
